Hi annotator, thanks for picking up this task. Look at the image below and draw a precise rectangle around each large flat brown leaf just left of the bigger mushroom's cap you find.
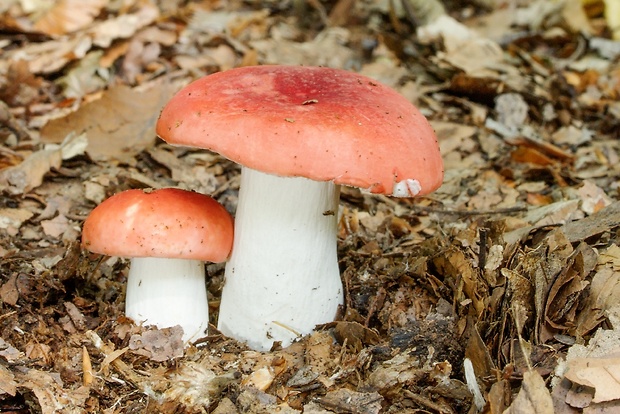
[41,81,173,160]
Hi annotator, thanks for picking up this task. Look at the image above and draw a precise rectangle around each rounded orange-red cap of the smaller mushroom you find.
[82,188,233,262]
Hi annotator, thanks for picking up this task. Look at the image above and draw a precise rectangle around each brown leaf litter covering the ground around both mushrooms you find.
[0,0,620,413]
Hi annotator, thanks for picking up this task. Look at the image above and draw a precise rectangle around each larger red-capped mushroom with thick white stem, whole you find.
[157,66,443,350]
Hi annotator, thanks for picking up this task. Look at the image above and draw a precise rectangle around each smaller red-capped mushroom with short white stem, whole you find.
[82,188,233,343]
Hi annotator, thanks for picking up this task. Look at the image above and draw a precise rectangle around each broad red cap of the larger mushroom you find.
[157,66,443,195]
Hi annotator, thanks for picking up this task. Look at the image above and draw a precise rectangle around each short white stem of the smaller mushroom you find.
[125,257,209,343]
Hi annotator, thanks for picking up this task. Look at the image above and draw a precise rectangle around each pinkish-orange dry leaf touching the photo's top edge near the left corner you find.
[34,0,108,35]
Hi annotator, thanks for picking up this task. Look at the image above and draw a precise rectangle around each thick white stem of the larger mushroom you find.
[218,168,343,350]
